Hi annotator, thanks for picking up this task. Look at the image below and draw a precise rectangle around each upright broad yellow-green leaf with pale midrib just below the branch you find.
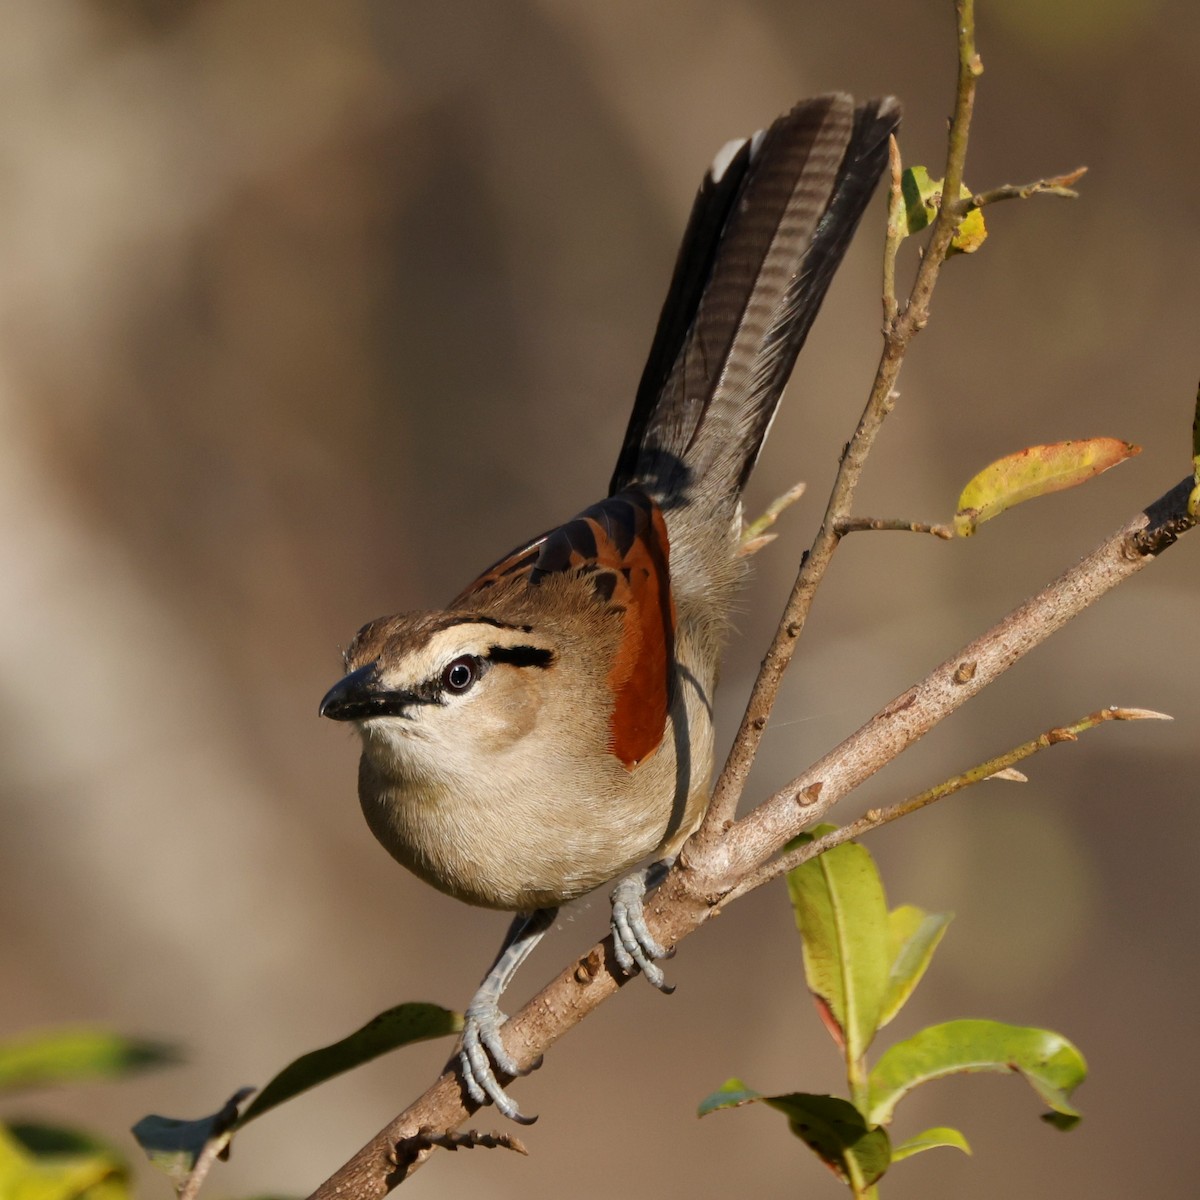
[787,826,890,1061]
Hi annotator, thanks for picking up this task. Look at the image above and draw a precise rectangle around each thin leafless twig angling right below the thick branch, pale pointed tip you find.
[725,708,1171,904]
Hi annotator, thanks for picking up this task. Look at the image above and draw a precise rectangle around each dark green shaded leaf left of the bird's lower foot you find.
[238,1003,462,1128]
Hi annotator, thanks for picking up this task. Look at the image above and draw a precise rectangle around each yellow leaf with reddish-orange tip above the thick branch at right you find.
[954,438,1141,538]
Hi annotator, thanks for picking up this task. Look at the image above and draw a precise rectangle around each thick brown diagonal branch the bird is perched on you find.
[314,475,1195,1200]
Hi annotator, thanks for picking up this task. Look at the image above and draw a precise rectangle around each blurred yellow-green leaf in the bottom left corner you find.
[0,1126,130,1200]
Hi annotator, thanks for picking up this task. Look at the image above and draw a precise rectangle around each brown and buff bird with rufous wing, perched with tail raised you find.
[319,92,900,1123]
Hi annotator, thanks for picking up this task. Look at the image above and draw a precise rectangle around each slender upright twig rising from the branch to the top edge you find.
[694,0,983,850]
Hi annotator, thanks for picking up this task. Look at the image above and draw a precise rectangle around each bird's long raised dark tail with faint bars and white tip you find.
[611,94,900,511]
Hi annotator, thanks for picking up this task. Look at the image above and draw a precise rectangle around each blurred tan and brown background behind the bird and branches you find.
[0,0,1200,1200]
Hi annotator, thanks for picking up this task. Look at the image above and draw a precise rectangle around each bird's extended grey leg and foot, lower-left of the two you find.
[458,908,558,1124]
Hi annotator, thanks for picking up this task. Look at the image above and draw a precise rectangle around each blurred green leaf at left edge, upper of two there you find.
[0,1028,179,1088]
